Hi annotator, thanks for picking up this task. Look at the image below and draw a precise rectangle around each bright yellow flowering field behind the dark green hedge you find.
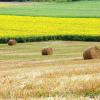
[0,15,100,38]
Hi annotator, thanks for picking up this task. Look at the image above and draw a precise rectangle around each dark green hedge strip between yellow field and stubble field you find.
[0,35,100,43]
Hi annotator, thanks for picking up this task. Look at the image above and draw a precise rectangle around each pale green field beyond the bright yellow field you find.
[0,1,100,17]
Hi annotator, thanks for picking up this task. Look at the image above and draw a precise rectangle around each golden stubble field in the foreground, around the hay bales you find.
[0,41,100,100]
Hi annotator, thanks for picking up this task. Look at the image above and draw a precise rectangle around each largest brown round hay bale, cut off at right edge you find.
[83,46,100,60]
